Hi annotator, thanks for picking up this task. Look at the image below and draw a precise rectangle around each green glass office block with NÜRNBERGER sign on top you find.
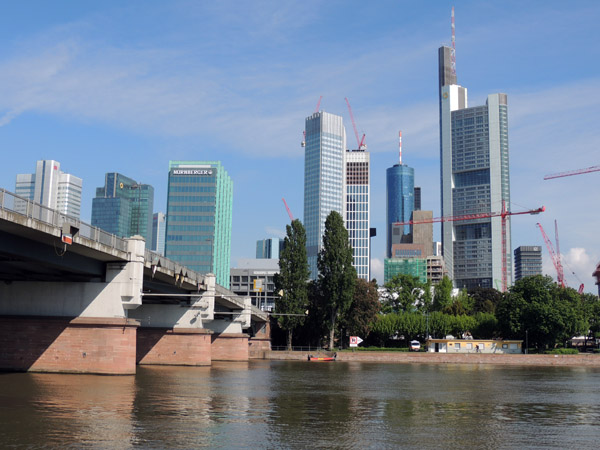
[165,161,233,288]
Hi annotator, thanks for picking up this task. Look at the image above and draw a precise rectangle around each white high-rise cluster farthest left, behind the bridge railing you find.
[14,160,83,218]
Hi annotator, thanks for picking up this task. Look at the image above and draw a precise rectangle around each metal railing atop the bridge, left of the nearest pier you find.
[0,188,127,251]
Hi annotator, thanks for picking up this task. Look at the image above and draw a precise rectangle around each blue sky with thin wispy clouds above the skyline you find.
[0,0,600,293]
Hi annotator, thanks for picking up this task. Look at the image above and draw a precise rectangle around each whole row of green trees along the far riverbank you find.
[274,212,600,350]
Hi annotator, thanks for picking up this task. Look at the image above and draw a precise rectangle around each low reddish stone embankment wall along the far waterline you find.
[265,351,600,368]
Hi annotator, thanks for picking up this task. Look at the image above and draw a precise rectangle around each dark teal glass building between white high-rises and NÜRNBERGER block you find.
[92,172,154,244]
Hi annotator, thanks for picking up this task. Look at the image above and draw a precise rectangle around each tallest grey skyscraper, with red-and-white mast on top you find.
[438,47,512,288]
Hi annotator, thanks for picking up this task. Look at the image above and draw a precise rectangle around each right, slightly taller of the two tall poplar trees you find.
[317,211,356,349]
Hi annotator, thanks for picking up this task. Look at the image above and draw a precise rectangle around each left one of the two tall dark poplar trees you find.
[274,219,310,350]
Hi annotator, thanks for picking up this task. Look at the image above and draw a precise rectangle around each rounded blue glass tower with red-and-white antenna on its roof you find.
[385,164,415,258]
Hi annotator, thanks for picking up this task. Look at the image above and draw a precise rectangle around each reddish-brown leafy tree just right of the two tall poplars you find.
[344,278,381,339]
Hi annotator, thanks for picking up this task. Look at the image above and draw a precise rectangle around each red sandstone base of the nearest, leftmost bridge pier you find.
[0,316,139,375]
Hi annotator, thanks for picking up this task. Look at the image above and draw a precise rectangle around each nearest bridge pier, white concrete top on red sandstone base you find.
[0,238,144,375]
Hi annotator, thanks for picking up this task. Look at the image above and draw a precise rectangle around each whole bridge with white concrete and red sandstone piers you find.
[0,189,270,374]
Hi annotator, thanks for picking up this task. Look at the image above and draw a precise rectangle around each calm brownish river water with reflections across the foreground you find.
[0,361,600,449]
